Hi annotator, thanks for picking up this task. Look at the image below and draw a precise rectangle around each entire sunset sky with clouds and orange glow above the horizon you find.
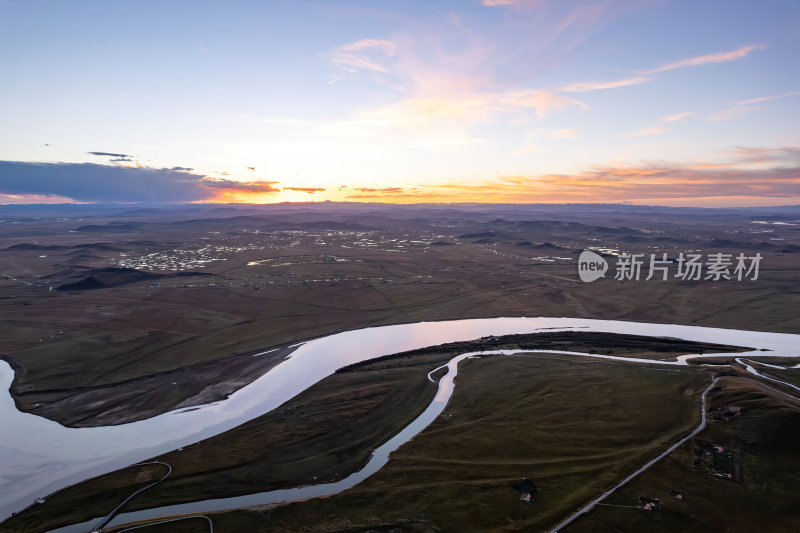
[0,0,800,206]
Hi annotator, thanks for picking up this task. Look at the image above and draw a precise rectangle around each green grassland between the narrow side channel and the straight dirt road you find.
[153,354,710,532]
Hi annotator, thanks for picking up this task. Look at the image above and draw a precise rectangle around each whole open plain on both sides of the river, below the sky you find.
[0,204,800,532]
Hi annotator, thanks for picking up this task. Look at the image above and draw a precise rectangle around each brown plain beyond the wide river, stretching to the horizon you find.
[0,202,800,425]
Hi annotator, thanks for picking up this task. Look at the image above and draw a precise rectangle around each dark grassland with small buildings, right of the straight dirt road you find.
[564,376,800,533]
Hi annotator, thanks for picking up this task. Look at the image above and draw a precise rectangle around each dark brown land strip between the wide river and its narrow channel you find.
[0,332,735,532]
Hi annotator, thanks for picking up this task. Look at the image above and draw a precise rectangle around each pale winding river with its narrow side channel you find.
[0,317,800,531]
